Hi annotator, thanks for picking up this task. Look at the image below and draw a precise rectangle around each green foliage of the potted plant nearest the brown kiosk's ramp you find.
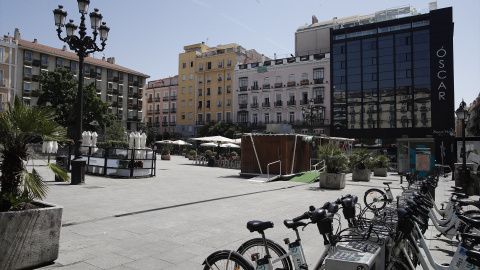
[318,144,348,173]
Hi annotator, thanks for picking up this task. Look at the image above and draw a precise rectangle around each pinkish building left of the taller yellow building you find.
[145,76,178,135]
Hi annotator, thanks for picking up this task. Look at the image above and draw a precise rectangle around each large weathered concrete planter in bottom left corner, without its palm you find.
[0,202,63,270]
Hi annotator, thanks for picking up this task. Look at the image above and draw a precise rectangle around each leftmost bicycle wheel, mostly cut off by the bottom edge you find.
[203,250,255,270]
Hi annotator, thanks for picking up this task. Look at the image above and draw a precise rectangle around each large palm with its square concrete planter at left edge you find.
[0,97,69,269]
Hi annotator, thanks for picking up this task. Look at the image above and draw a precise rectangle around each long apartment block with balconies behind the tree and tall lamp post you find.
[7,29,149,131]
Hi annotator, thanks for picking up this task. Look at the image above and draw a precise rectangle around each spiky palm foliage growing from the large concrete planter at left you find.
[0,97,69,211]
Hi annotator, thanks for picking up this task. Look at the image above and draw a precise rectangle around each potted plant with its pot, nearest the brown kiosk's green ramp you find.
[318,144,348,189]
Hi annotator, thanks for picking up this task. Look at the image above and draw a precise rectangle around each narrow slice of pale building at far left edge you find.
[0,36,18,112]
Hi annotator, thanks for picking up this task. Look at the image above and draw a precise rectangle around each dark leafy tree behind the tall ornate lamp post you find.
[37,68,116,138]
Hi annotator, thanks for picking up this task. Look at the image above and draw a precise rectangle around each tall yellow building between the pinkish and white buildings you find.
[177,43,262,137]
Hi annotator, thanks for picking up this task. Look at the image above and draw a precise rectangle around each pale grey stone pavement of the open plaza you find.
[28,156,456,270]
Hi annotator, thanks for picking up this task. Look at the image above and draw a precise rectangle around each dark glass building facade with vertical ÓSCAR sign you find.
[331,8,455,165]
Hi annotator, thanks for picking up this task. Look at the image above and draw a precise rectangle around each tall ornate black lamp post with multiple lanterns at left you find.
[53,0,110,185]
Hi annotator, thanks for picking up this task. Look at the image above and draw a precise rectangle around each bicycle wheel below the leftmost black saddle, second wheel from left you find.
[237,238,294,270]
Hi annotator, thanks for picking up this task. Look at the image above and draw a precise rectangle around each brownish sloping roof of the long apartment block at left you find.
[18,39,150,78]
